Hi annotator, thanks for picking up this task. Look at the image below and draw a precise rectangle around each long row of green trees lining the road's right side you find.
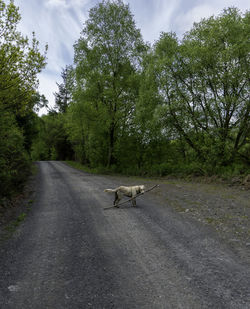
[32,0,250,175]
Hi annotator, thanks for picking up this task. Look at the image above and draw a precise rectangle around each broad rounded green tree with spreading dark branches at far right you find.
[141,8,250,168]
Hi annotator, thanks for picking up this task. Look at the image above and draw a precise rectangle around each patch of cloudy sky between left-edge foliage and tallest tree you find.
[16,0,89,106]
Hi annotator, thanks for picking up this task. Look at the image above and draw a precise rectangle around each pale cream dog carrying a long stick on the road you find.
[104,185,145,207]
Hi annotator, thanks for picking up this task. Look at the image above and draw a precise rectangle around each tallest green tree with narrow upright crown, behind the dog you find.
[74,0,145,166]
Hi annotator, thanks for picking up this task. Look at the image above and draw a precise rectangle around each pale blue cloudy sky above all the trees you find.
[15,0,250,113]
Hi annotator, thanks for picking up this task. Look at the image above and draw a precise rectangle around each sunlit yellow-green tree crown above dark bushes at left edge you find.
[0,0,47,113]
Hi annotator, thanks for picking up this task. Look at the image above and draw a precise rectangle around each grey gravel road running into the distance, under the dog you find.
[0,161,250,309]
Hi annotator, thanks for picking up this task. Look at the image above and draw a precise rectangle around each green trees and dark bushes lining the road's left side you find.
[0,0,47,200]
